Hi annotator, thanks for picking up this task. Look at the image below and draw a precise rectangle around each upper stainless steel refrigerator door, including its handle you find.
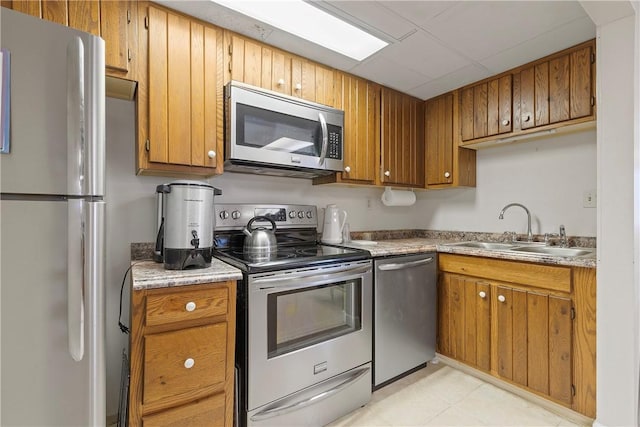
[0,8,105,196]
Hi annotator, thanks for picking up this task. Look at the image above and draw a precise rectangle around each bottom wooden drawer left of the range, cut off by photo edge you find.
[142,393,225,427]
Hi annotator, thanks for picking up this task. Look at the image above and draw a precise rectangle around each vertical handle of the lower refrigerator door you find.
[67,199,85,362]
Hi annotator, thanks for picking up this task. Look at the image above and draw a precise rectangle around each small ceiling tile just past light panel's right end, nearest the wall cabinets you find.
[349,56,429,93]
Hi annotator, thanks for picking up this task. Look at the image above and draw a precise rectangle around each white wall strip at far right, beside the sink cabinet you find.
[596,10,638,426]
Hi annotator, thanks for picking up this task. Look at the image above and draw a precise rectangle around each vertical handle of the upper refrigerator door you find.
[67,36,86,195]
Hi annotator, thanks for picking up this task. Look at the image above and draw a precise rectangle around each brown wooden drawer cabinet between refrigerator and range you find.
[129,281,236,427]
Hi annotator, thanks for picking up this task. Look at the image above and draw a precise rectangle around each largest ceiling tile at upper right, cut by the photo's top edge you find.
[423,1,586,61]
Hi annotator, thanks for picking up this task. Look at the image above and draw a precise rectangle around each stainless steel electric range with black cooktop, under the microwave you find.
[214,204,373,426]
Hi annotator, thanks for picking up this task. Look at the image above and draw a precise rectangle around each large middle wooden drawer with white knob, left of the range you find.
[142,322,227,404]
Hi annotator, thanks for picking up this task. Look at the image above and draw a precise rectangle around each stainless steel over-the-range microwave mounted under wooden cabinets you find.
[225,81,344,178]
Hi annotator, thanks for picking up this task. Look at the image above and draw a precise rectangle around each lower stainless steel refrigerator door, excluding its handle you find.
[0,200,105,426]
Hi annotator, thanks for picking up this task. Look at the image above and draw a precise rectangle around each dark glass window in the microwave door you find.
[236,103,322,157]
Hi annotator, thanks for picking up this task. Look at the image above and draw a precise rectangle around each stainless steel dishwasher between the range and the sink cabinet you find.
[373,253,437,388]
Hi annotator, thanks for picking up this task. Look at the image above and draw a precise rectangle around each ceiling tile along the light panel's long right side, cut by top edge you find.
[314,0,415,41]
